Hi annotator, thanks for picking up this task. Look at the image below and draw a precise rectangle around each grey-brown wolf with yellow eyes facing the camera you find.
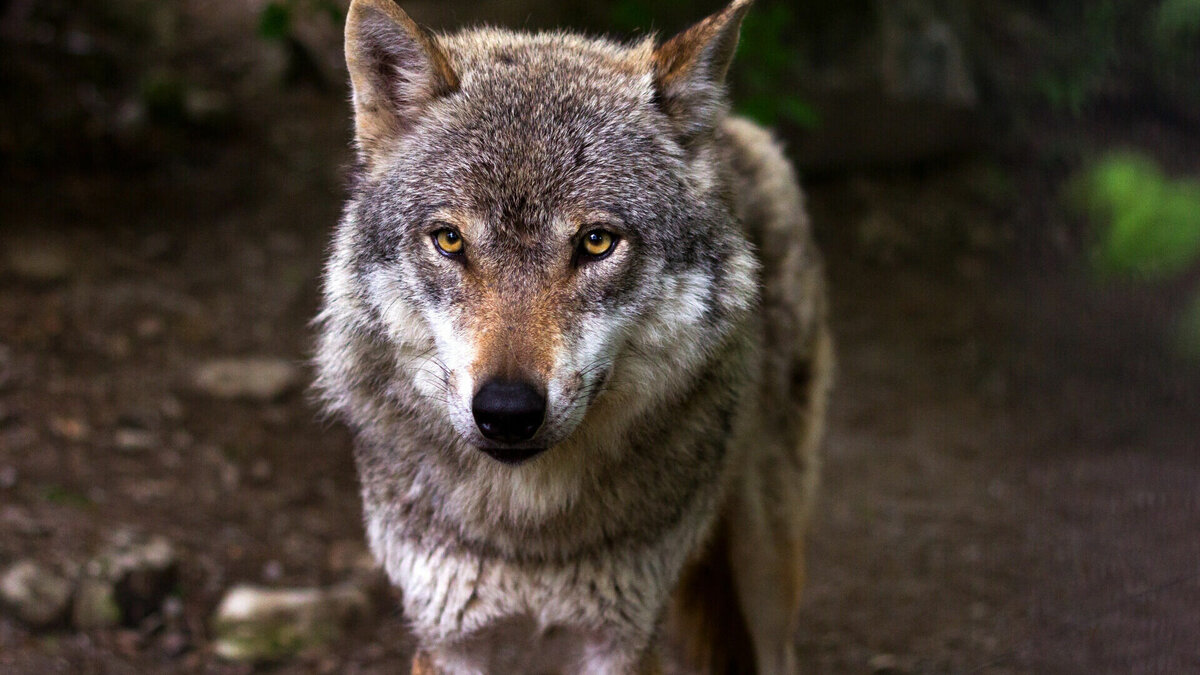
[316,0,833,674]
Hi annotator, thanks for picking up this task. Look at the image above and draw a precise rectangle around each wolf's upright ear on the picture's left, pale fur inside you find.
[346,0,458,160]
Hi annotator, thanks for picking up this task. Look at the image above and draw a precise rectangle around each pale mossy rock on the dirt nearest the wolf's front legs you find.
[212,584,371,662]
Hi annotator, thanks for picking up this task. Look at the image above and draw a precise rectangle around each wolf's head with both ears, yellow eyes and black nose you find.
[320,0,755,462]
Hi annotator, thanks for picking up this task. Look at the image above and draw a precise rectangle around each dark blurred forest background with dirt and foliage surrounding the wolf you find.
[0,0,1200,674]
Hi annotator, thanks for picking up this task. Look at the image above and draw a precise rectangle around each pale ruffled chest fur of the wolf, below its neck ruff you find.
[367,511,696,653]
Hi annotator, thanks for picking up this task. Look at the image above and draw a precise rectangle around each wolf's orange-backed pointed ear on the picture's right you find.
[654,0,752,139]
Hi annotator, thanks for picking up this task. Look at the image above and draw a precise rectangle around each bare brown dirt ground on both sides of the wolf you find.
[0,2,1200,674]
